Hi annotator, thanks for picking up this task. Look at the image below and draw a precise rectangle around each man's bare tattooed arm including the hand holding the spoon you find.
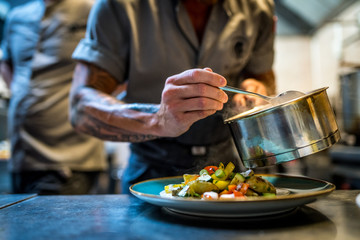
[70,63,228,142]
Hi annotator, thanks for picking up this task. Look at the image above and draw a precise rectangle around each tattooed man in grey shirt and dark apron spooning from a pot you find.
[70,0,275,193]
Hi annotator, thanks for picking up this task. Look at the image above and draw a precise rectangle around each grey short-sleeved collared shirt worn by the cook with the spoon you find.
[73,0,274,152]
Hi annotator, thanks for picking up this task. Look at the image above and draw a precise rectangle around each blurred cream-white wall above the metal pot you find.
[274,2,360,104]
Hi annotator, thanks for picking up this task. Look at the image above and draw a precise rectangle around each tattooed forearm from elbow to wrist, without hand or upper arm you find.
[71,87,159,142]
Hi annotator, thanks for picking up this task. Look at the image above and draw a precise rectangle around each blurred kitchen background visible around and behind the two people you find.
[0,0,360,193]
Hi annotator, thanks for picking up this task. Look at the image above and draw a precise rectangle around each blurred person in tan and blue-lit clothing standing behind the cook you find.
[1,0,107,194]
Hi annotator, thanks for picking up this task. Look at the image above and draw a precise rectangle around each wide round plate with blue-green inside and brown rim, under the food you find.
[130,174,335,217]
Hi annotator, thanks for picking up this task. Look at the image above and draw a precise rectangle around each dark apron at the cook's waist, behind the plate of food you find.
[121,113,240,193]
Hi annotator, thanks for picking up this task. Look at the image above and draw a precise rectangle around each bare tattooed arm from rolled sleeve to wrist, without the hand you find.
[70,63,164,142]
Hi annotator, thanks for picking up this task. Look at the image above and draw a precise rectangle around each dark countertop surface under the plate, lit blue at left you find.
[0,190,360,240]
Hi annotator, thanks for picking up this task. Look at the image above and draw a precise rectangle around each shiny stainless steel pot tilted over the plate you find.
[225,87,340,168]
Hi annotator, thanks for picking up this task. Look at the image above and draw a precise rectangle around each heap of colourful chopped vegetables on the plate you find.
[160,162,276,200]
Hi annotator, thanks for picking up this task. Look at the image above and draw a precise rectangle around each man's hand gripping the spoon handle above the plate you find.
[156,69,228,137]
